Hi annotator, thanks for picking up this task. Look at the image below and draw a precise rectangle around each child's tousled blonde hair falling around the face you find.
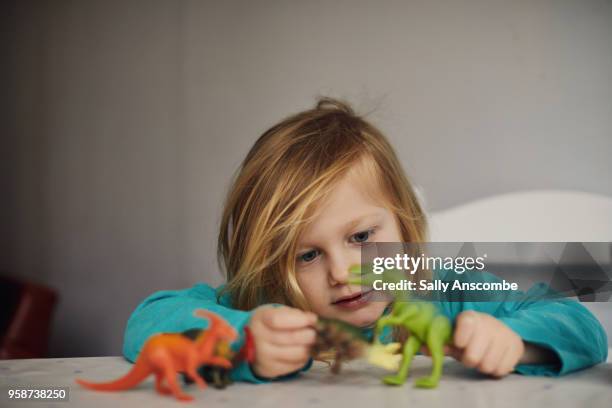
[217,98,427,310]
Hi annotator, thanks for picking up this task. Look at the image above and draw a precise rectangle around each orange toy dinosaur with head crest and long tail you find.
[76,309,244,401]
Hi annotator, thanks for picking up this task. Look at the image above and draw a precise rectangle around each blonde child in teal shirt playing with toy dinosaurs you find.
[123,98,607,382]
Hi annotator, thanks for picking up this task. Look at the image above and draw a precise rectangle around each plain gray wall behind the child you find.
[0,0,612,356]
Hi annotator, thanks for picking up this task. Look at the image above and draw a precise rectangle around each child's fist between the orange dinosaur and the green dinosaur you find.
[249,306,317,378]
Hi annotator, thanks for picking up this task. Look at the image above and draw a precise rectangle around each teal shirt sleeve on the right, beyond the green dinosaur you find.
[442,271,608,376]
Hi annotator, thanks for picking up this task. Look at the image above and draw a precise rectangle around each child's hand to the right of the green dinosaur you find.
[446,311,525,377]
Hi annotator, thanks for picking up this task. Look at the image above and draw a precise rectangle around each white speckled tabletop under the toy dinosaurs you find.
[0,350,612,408]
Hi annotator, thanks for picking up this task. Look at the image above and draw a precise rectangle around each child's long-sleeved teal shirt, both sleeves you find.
[123,271,608,383]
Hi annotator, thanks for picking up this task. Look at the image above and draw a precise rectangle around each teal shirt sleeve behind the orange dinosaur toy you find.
[123,284,311,383]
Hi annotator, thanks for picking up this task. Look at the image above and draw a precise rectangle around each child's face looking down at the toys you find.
[296,166,402,327]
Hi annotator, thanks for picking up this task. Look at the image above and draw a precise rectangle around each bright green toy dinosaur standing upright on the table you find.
[349,265,453,388]
